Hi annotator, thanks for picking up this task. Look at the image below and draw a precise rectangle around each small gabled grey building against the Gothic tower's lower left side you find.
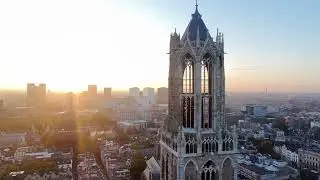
[142,157,161,180]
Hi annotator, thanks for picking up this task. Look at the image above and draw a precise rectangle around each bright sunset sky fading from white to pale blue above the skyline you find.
[0,0,320,92]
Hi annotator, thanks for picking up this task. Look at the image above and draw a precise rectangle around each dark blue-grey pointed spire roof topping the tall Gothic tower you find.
[185,5,208,41]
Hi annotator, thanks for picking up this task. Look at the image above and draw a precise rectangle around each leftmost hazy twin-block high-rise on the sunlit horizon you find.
[27,83,47,106]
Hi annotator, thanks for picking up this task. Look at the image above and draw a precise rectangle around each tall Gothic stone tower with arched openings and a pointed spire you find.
[160,5,237,180]
